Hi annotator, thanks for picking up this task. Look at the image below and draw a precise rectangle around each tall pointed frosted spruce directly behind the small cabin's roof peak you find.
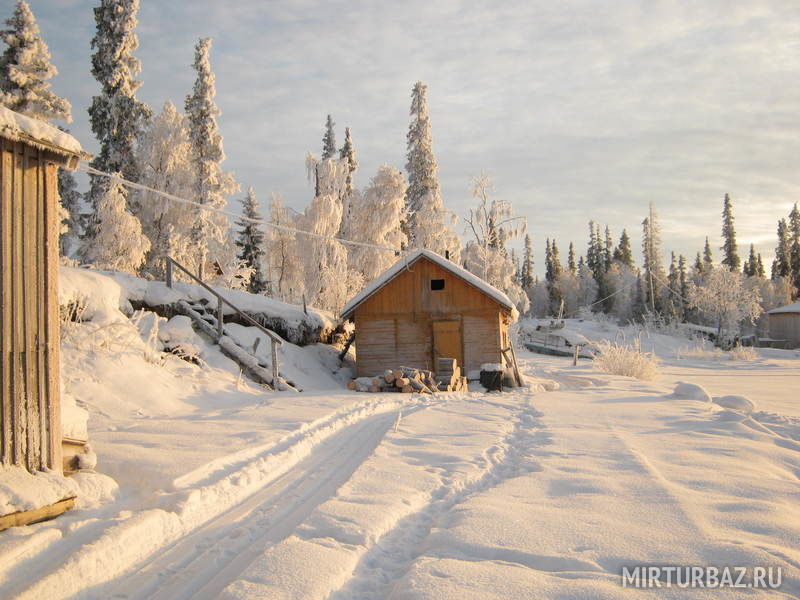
[404,81,461,263]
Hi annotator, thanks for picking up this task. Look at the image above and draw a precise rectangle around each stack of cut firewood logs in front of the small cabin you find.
[347,358,467,394]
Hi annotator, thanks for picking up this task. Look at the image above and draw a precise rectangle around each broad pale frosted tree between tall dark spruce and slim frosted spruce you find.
[130,101,196,278]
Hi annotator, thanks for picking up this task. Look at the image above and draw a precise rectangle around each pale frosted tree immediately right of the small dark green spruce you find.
[266,194,308,304]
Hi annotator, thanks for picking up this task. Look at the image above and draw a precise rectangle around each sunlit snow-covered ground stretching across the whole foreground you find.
[0,310,800,600]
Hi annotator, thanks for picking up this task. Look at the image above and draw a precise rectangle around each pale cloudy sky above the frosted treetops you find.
[25,0,800,273]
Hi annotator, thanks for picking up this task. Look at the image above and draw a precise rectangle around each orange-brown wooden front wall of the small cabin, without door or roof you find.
[354,257,509,377]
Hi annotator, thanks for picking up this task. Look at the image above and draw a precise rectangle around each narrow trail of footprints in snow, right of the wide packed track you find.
[329,403,545,600]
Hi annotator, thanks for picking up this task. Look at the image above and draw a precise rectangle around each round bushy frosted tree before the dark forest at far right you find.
[688,268,761,340]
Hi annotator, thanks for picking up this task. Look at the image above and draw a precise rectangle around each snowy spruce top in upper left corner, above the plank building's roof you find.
[0,0,72,123]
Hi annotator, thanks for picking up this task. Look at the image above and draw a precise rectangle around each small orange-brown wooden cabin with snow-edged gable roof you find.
[342,250,517,377]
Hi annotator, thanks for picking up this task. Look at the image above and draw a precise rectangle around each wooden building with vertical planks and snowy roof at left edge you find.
[0,106,82,473]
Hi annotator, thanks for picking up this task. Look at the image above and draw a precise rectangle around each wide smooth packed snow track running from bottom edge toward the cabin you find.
[99,414,396,600]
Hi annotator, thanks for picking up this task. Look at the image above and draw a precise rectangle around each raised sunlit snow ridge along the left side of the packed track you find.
[10,395,430,600]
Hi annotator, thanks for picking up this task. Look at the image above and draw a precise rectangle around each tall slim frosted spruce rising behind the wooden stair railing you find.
[185,38,239,276]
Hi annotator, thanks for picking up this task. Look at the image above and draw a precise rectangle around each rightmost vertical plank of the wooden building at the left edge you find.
[43,164,61,469]
